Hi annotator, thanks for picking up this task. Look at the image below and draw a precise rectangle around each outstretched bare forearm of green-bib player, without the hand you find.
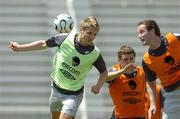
[17,40,47,51]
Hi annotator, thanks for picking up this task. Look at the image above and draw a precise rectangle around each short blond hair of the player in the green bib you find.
[80,16,100,32]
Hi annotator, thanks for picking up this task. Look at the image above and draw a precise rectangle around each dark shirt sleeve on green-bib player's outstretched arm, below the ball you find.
[46,34,68,47]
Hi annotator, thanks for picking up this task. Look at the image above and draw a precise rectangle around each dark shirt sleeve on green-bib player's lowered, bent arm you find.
[93,54,107,73]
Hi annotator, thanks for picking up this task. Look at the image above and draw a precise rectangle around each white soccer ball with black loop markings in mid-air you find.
[54,14,74,33]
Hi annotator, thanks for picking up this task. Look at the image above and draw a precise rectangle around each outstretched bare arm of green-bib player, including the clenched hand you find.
[9,40,48,52]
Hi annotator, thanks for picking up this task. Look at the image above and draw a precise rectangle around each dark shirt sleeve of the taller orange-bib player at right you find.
[142,60,157,82]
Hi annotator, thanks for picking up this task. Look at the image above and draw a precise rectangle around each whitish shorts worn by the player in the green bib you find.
[49,86,83,116]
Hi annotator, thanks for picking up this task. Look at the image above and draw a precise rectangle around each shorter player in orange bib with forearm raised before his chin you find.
[107,45,146,119]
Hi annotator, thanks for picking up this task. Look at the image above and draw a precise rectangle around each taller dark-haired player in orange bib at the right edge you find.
[137,20,180,119]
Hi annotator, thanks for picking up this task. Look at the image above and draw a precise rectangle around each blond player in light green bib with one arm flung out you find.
[9,16,107,119]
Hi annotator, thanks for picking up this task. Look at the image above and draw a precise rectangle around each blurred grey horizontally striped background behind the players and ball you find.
[0,0,180,119]
